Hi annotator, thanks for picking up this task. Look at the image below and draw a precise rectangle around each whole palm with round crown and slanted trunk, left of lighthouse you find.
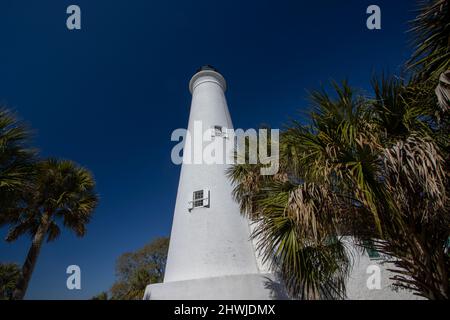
[6,159,98,299]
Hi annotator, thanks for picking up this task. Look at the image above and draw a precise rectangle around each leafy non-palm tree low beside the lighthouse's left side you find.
[110,237,169,300]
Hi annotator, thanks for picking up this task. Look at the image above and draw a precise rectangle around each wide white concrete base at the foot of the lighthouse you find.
[144,273,288,300]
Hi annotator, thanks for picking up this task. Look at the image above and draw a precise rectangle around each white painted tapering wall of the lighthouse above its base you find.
[164,70,259,283]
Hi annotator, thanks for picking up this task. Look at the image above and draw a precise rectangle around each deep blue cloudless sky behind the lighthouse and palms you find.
[0,0,414,299]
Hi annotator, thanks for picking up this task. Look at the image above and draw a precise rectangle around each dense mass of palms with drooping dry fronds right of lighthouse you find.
[229,79,450,299]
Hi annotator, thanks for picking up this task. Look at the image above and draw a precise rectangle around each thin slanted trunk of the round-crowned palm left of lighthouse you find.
[13,212,50,300]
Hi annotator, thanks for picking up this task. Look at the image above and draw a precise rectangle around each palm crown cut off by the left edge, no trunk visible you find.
[0,108,34,220]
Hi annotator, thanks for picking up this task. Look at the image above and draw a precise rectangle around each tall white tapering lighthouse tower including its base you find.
[144,66,283,300]
